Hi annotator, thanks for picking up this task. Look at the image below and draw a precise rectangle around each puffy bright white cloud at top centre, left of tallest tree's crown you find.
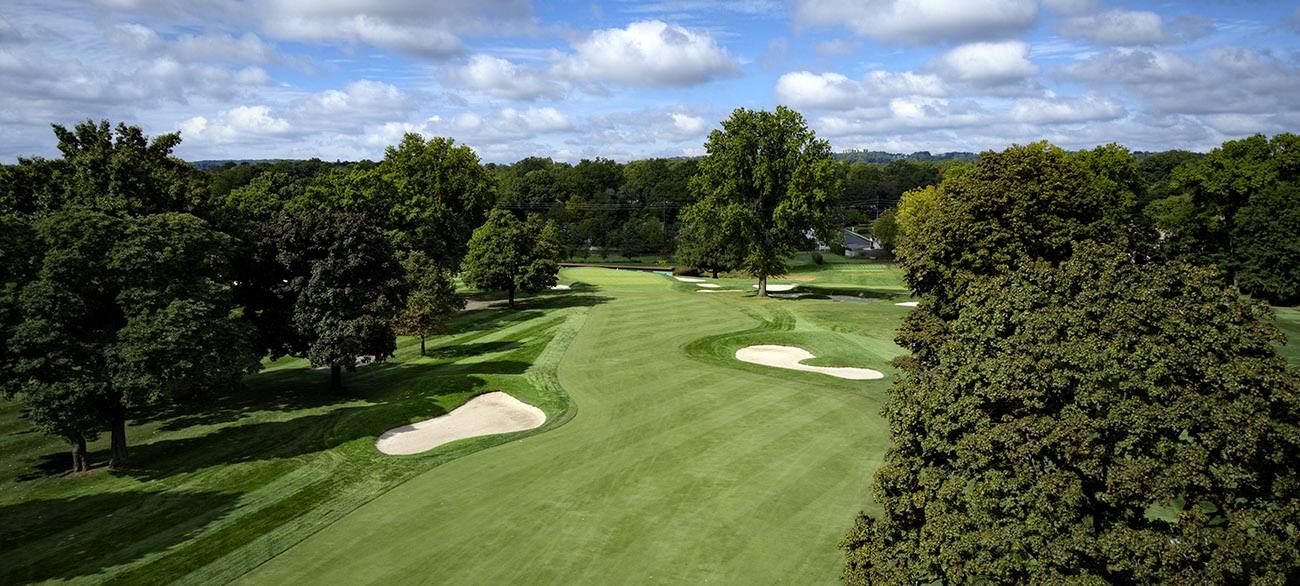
[560,21,741,87]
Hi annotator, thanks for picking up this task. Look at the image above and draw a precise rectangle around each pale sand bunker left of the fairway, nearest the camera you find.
[374,391,546,455]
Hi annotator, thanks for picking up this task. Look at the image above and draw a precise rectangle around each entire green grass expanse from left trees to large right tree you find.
[0,262,904,583]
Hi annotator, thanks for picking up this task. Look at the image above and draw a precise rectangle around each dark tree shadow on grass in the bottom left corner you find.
[0,490,237,583]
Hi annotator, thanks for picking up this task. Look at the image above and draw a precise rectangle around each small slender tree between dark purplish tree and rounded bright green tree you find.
[394,251,465,356]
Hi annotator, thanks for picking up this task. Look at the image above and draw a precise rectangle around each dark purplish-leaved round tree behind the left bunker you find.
[250,212,407,391]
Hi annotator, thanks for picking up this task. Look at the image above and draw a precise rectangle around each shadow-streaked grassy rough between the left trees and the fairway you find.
[0,295,590,583]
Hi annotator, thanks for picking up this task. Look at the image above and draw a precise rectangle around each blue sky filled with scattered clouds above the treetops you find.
[0,0,1300,162]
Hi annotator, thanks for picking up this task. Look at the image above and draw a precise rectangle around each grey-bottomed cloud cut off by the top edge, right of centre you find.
[794,0,1039,45]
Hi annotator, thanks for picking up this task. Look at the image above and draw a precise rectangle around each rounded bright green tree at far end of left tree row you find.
[463,209,561,305]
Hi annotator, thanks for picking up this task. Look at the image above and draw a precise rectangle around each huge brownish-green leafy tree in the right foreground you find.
[841,246,1300,586]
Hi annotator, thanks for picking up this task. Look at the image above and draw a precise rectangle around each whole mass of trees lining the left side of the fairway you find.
[0,121,558,472]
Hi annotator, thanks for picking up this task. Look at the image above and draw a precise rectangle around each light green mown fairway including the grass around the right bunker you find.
[238,269,904,585]
